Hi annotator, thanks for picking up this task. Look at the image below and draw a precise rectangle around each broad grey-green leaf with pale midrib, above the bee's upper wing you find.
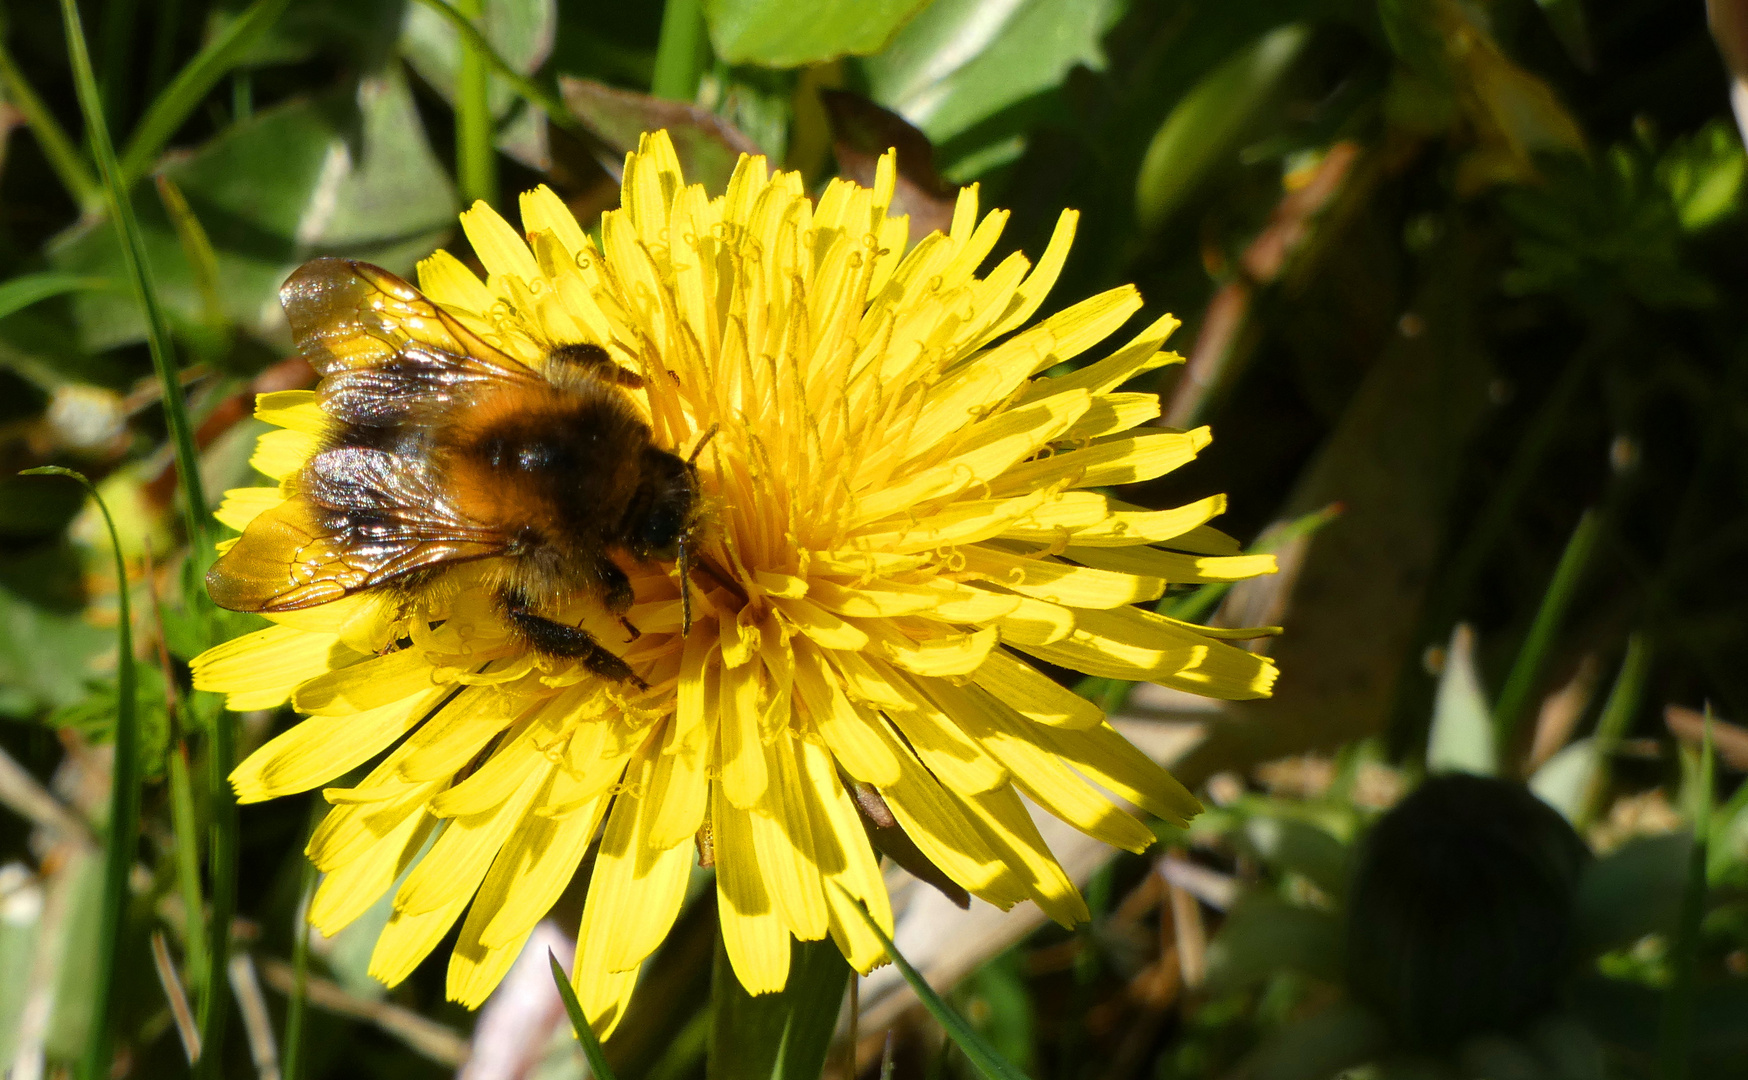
[51,68,456,350]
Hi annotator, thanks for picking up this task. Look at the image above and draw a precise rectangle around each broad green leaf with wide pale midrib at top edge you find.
[862,0,1124,143]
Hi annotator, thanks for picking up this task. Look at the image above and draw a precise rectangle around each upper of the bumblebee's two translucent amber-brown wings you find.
[280,259,542,426]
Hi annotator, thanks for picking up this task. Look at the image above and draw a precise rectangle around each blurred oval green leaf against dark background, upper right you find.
[1134,23,1311,229]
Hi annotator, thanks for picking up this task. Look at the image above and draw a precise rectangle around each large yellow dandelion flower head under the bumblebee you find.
[194,131,1274,1029]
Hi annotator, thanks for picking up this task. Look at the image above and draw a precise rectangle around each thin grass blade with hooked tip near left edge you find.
[24,465,142,1080]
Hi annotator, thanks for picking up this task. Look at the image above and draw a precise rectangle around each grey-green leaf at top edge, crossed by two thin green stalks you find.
[400,0,558,170]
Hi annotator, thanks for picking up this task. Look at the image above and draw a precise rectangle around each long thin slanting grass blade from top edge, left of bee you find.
[61,0,208,552]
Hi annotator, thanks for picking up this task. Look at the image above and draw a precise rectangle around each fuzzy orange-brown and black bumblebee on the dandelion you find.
[206,259,708,682]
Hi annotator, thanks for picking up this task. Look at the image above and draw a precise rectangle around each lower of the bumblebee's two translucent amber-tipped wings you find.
[206,446,509,612]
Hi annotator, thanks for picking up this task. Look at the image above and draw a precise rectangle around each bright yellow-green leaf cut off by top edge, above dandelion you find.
[704,0,928,68]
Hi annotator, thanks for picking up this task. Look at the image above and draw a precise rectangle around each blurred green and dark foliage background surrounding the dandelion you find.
[0,0,1748,1080]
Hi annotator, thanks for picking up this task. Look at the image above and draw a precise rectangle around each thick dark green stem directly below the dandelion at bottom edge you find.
[710,938,850,1080]
